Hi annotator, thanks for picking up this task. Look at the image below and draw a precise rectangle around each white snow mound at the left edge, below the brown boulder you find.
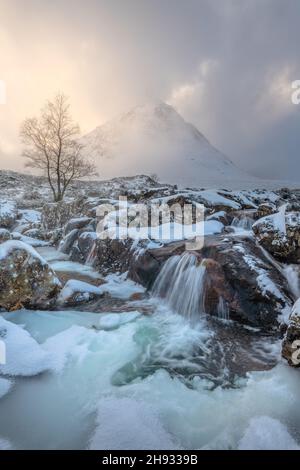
[0,316,53,378]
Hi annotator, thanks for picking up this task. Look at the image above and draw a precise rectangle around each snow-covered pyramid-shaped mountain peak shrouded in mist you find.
[81,102,255,187]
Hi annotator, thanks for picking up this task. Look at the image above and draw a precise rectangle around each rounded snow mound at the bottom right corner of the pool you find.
[238,416,300,450]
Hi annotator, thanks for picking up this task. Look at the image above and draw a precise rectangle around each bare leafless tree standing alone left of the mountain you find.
[21,94,97,202]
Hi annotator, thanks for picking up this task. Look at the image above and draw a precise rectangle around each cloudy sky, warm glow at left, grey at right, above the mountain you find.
[0,0,300,180]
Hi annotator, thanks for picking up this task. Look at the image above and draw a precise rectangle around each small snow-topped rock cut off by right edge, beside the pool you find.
[282,299,300,367]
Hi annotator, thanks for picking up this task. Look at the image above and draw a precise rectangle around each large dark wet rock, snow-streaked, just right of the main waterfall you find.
[198,238,292,328]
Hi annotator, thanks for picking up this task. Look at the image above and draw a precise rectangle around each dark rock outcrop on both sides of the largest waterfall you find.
[129,237,292,329]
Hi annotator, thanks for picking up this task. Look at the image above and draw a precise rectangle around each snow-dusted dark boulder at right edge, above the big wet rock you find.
[252,208,300,264]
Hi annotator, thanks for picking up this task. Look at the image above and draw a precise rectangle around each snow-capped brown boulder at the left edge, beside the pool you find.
[0,240,61,310]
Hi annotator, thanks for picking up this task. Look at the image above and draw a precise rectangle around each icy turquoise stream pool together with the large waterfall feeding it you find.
[0,251,300,450]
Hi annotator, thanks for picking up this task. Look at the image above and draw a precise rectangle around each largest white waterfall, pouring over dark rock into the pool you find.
[152,253,205,319]
